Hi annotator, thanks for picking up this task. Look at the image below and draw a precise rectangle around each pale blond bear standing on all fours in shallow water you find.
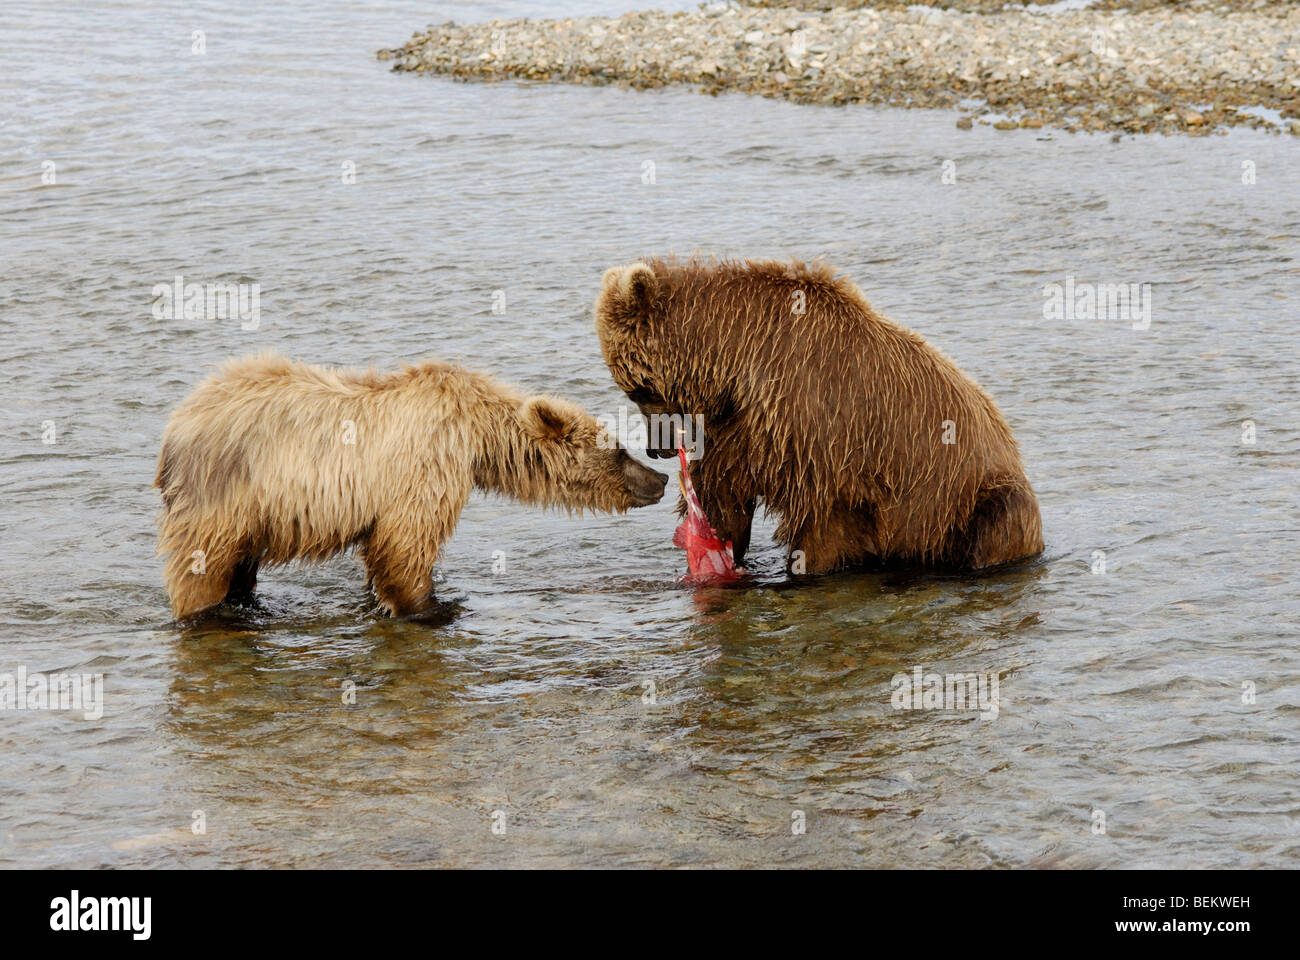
[153,355,667,618]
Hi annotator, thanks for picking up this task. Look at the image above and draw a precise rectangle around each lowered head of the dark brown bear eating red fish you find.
[595,261,735,458]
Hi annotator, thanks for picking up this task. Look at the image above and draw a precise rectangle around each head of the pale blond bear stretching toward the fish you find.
[503,395,668,513]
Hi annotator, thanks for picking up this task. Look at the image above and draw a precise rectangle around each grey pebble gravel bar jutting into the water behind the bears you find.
[378,0,1300,135]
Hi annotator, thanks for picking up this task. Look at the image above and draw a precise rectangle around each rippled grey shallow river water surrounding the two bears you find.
[0,1,1300,866]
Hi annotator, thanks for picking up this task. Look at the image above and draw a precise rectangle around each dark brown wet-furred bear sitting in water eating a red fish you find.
[595,258,1043,574]
